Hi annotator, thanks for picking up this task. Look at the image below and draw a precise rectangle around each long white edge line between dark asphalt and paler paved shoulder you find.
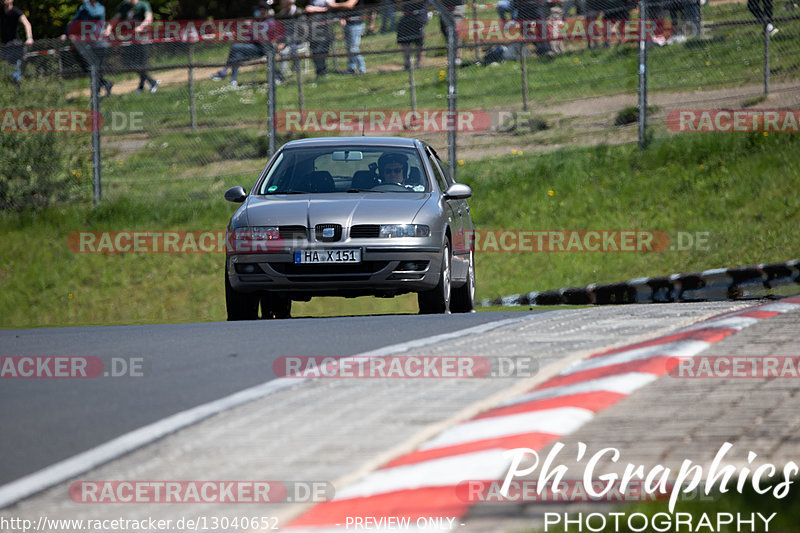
[0,314,534,509]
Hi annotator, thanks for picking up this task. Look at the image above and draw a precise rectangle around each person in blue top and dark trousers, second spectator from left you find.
[61,0,114,96]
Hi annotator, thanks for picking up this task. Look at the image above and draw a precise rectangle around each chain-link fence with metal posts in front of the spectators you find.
[0,0,800,205]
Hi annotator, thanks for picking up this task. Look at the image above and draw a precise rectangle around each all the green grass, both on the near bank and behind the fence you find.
[0,4,800,327]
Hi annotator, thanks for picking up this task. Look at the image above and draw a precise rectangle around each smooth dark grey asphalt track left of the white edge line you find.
[0,312,520,485]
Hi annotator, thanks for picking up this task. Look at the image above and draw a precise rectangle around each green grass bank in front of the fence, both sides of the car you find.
[0,134,800,327]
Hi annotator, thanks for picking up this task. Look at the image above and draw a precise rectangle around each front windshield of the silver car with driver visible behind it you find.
[258,145,431,194]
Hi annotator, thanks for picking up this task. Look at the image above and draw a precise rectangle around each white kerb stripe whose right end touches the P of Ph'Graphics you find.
[333,449,511,501]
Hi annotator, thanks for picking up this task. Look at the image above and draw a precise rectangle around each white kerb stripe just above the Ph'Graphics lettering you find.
[419,407,594,450]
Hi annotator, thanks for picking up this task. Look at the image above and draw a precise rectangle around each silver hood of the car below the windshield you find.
[247,192,431,228]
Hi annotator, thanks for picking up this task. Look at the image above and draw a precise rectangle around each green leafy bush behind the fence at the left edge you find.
[0,73,91,209]
